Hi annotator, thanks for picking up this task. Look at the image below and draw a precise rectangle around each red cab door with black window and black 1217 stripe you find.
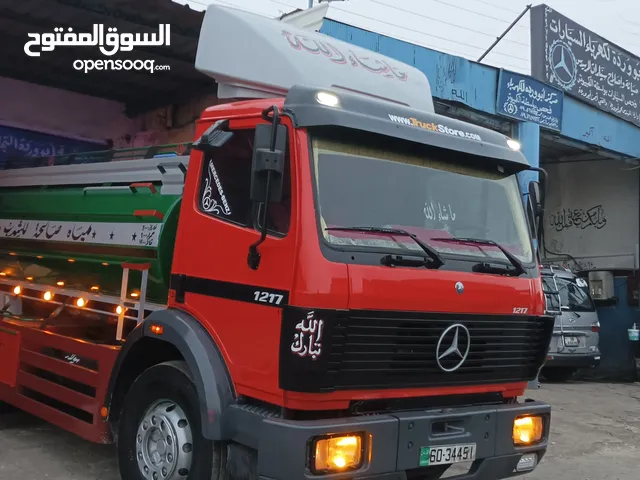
[170,118,297,400]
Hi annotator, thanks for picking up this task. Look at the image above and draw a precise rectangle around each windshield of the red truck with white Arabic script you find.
[312,130,533,264]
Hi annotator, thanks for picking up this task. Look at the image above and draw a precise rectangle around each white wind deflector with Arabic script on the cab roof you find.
[195,5,434,112]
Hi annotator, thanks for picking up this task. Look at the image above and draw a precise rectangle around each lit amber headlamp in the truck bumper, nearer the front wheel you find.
[313,434,364,473]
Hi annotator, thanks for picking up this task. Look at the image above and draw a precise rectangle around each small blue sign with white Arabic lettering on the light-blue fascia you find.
[496,70,564,131]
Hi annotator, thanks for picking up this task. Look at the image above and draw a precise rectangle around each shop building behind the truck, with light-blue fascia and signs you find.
[0,0,640,372]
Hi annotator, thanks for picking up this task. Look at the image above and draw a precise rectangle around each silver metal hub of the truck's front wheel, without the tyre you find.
[136,400,193,480]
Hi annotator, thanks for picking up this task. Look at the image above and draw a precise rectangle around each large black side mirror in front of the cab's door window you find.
[250,124,287,203]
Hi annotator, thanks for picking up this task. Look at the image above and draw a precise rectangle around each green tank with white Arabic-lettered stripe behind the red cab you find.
[0,185,181,302]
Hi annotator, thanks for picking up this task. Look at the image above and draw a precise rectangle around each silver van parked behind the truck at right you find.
[542,265,600,381]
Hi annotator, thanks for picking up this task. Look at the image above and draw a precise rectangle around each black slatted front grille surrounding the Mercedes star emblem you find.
[328,311,553,390]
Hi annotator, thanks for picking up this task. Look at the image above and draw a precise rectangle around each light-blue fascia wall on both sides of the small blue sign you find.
[320,19,640,163]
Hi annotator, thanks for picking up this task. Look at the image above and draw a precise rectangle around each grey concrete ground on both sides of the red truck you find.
[0,382,640,480]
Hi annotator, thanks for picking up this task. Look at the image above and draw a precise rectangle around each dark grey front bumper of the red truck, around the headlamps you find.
[254,401,551,480]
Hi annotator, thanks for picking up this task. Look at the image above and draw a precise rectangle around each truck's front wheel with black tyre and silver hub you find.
[118,362,216,480]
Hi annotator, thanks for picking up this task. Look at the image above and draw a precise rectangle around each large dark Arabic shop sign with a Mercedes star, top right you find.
[531,4,640,126]
